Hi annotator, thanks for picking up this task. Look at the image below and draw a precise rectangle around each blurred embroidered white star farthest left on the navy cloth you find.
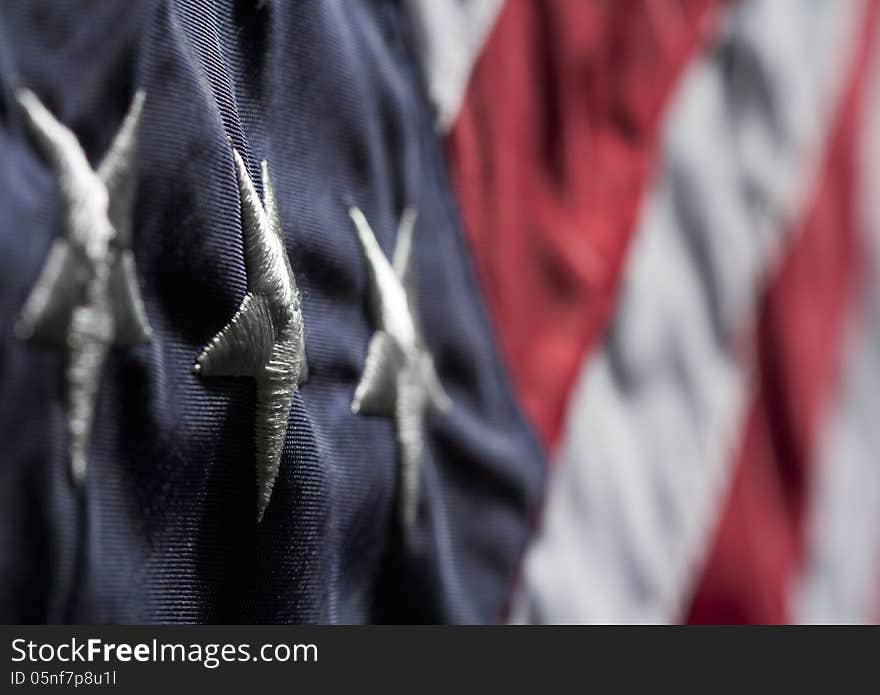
[16,89,151,484]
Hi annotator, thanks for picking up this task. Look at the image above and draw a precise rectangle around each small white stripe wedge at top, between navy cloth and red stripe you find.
[406,0,503,132]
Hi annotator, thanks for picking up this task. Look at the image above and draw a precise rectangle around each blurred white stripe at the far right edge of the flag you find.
[792,38,880,623]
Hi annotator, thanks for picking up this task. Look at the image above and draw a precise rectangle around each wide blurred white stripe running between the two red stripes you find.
[513,0,862,622]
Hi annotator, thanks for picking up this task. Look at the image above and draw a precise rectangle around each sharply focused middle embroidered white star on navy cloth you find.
[193,148,307,523]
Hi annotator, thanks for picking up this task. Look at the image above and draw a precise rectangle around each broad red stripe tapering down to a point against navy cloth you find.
[447,0,720,448]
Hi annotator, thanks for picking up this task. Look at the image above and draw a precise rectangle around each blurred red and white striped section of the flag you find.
[409,0,880,623]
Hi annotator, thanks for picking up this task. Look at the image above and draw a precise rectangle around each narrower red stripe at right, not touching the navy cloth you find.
[688,2,878,623]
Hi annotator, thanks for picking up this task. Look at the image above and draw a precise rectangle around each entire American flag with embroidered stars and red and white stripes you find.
[0,0,880,623]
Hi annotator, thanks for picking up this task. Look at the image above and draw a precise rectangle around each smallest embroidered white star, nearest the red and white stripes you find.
[348,207,451,527]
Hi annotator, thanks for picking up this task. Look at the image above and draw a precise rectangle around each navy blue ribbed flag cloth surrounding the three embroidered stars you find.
[0,0,544,623]
